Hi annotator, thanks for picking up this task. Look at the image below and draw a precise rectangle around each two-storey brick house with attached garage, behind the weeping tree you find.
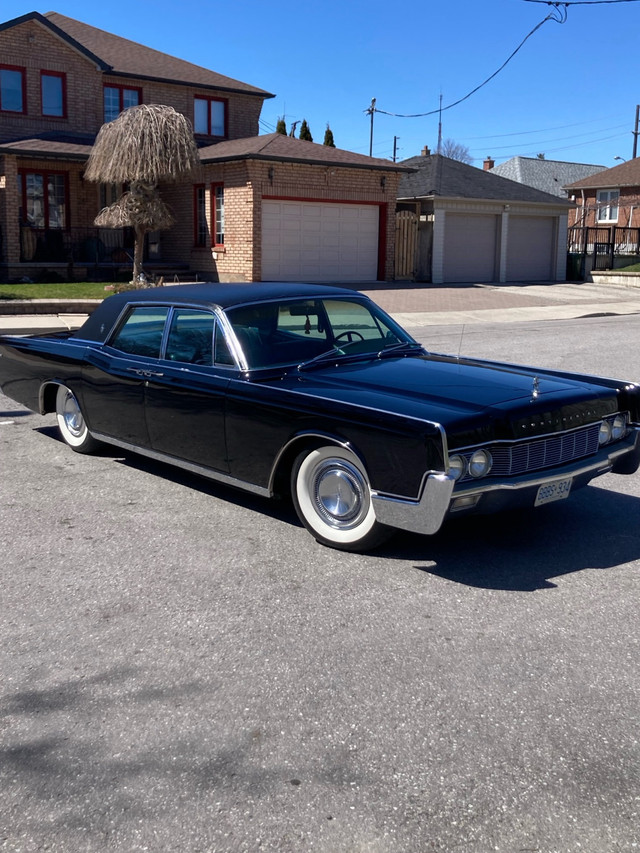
[0,12,404,282]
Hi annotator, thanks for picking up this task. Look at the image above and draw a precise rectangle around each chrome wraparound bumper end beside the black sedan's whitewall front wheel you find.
[371,474,455,534]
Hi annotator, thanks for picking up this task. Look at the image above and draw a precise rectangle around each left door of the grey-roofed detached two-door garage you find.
[444,213,498,282]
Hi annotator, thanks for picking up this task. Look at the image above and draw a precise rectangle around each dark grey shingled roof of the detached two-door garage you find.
[398,154,573,207]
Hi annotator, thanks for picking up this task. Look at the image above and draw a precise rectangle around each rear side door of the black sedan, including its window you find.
[82,305,170,448]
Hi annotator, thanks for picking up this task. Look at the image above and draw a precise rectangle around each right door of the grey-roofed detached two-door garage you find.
[507,216,555,281]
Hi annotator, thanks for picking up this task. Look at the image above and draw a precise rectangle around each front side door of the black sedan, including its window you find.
[145,307,232,472]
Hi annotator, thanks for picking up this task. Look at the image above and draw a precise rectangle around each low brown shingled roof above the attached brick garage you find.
[200,133,407,172]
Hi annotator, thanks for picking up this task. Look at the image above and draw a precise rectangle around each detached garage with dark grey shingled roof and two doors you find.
[396,148,573,284]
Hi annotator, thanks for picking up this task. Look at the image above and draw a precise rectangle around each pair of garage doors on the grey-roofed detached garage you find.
[444,213,555,283]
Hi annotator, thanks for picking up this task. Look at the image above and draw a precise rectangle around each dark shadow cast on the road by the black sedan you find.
[37,427,640,591]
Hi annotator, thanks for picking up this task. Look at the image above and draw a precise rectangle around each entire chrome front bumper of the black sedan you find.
[371,425,640,534]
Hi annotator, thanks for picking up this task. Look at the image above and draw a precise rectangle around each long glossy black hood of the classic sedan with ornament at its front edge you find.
[272,355,616,445]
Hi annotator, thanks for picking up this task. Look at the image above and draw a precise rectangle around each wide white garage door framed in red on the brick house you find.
[262,200,379,281]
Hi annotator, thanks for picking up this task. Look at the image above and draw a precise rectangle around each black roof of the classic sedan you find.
[72,282,366,341]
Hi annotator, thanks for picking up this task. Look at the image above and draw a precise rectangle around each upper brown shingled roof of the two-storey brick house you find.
[0,12,274,98]
